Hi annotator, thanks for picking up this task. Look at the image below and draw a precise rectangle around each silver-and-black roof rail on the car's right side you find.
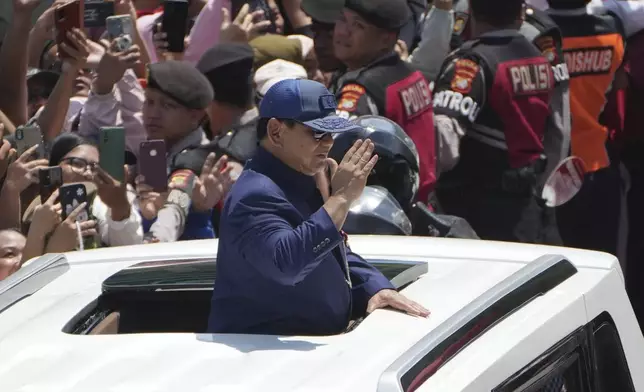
[377,255,577,392]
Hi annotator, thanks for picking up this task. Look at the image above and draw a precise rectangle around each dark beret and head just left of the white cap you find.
[197,43,254,107]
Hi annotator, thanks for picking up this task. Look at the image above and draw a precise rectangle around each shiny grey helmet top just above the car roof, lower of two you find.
[342,186,412,235]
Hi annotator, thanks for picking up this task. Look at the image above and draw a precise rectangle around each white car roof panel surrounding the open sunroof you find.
[0,236,619,392]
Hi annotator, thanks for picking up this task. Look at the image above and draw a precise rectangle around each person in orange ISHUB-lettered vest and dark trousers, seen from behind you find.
[547,0,625,255]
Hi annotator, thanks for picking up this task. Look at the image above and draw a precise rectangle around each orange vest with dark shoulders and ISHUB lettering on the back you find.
[548,8,625,172]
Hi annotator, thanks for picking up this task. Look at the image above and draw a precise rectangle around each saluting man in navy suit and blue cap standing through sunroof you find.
[208,79,429,335]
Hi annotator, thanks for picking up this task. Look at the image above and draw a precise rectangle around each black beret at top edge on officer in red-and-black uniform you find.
[344,0,412,31]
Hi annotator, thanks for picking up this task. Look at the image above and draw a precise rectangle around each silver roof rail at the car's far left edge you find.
[0,254,70,313]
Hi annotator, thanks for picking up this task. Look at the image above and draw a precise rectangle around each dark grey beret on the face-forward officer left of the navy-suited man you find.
[147,61,214,109]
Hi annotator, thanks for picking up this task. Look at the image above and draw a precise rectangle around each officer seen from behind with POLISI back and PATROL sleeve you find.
[434,0,559,243]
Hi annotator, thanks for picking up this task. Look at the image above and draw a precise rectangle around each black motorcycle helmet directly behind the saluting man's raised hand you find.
[329,116,419,211]
